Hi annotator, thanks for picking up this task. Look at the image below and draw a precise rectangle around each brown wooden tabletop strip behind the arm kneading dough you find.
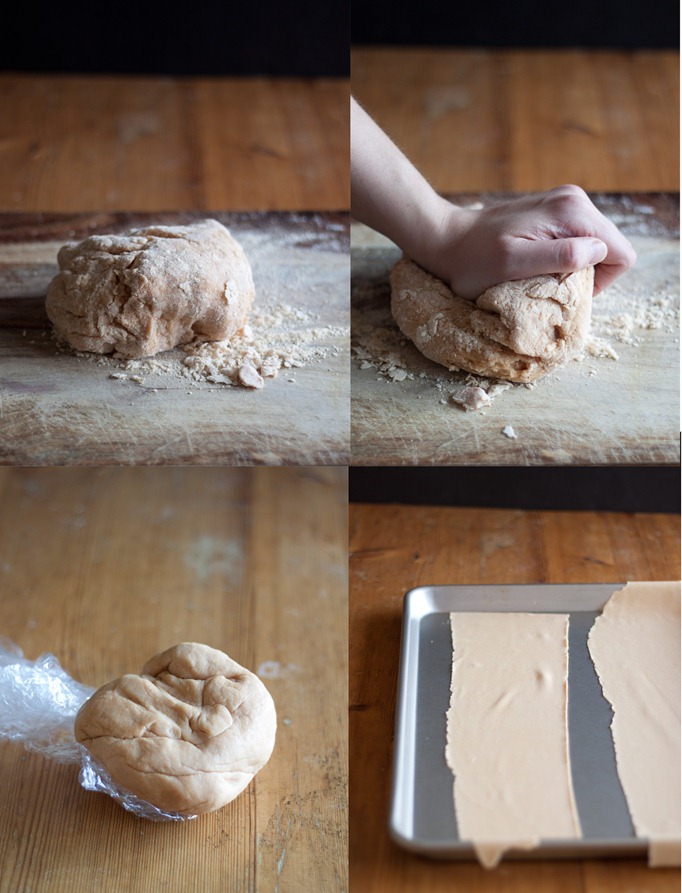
[351,47,679,193]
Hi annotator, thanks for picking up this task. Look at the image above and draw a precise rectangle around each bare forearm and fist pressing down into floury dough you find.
[351,100,635,298]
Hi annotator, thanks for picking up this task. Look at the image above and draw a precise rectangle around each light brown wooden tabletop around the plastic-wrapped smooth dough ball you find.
[0,468,347,893]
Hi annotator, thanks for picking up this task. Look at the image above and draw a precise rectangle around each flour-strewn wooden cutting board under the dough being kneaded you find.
[351,194,680,465]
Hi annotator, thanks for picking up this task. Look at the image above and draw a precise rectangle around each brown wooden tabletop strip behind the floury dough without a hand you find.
[0,73,349,212]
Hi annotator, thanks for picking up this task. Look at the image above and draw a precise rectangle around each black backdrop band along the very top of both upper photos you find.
[0,0,679,77]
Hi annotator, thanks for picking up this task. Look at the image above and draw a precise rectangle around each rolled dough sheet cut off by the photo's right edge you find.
[587,583,680,866]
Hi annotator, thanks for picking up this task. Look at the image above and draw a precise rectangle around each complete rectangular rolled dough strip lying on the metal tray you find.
[446,612,581,868]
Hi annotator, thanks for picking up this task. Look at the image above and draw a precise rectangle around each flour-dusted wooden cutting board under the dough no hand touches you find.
[0,212,350,465]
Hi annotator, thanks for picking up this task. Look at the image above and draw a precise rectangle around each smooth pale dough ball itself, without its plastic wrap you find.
[74,642,277,815]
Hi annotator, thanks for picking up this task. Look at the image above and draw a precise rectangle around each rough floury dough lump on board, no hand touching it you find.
[45,220,254,358]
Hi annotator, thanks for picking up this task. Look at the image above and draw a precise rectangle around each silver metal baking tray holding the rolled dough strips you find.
[390,583,648,859]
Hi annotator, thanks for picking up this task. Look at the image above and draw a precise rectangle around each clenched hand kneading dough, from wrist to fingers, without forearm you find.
[424,186,636,298]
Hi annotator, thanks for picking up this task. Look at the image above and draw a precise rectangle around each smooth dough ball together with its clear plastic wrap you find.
[0,637,277,821]
